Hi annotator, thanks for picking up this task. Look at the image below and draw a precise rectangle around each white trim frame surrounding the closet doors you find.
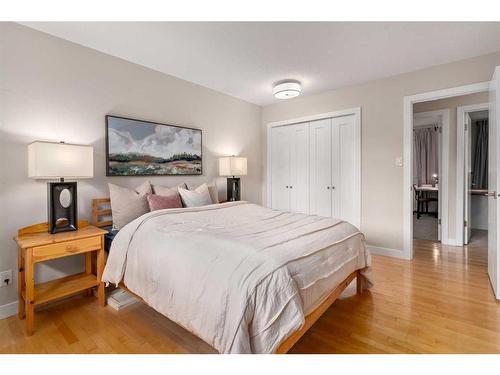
[265,107,361,228]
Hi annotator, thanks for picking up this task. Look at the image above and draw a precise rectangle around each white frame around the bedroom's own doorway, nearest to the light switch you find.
[402,81,490,260]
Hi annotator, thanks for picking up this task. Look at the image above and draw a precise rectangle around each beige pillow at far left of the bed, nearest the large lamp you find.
[108,181,152,229]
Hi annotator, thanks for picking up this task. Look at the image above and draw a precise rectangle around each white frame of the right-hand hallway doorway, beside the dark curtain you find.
[455,103,490,246]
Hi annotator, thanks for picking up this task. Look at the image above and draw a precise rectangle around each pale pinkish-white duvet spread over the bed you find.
[103,202,370,353]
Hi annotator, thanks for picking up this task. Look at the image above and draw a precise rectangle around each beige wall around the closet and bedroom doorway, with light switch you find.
[261,53,500,254]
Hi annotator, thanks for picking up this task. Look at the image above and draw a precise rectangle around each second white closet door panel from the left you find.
[290,123,309,214]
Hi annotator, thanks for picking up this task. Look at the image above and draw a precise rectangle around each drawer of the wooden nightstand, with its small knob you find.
[33,237,101,262]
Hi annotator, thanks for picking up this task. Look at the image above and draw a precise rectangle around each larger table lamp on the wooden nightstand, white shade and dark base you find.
[28,141,94,233]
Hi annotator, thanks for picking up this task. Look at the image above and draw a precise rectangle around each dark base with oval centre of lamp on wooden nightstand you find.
[47,181,78,233]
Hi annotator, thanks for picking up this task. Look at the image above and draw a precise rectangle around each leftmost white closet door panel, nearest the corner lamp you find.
[271,126,291,211]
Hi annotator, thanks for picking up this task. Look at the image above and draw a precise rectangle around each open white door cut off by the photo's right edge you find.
[488,66,500,299]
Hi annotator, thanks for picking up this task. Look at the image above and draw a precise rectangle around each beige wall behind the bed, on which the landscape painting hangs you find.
[0,23,262,312]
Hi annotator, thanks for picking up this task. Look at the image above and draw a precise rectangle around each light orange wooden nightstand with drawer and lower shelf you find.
[15,221,107,335]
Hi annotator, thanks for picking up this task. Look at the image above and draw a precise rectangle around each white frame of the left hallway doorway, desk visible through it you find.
[411,109,454,245]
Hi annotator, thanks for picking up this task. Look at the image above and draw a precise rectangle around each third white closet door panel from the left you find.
[309,119,332,216]
